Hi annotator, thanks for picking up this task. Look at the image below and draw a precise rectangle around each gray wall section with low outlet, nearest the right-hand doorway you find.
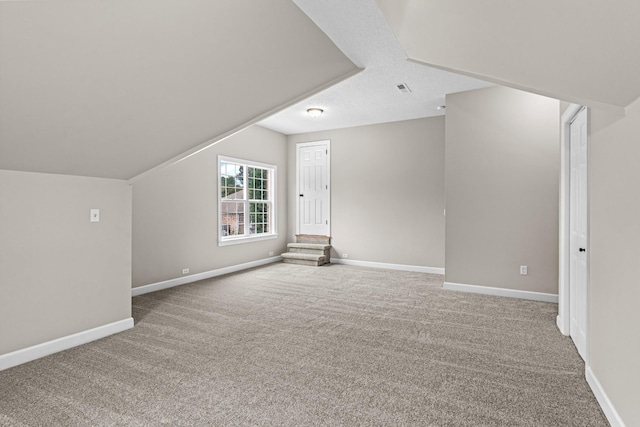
[446,87,560,294]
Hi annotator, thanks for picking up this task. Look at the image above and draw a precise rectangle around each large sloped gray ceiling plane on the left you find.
[0,0,358,179]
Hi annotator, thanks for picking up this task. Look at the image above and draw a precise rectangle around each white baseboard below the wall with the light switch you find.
[0,317,133,371]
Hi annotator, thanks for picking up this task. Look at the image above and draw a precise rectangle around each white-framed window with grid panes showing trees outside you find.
[218,156,276,245]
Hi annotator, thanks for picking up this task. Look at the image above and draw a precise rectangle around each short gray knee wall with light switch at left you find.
[0,170,131,354]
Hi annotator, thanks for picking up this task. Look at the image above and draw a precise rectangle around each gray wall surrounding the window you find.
[133,126,287,287]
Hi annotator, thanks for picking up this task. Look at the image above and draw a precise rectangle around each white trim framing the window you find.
[216,155,278,246]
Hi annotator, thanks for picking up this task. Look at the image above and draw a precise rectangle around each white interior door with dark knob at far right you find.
[569,108,589,359]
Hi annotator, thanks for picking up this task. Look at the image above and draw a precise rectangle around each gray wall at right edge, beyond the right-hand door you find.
[589,101,640,426]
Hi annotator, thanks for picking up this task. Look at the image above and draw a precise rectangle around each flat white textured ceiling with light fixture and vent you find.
[259,0,492,135]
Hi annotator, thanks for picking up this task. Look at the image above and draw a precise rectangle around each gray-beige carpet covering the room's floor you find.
[0,264,607,426]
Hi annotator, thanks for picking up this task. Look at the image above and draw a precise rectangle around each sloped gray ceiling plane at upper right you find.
[377,0,640,111]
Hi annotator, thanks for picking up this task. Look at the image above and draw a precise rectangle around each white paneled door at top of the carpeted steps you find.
[297,141,330,236]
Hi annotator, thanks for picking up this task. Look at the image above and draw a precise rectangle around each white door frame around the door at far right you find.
[556,104,591,366]
